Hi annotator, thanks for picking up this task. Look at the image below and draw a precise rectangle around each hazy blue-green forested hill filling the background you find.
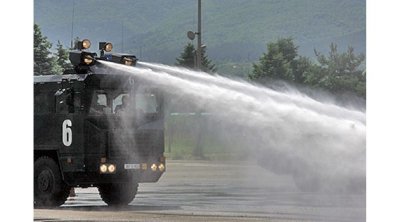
[34,0,366,73]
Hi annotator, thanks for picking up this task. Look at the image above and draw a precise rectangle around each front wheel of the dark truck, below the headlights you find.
[98,183,139,206]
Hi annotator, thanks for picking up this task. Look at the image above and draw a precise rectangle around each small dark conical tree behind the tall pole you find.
[175,43,216,72]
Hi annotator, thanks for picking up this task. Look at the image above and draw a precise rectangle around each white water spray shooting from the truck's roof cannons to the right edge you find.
[93,61,366,193]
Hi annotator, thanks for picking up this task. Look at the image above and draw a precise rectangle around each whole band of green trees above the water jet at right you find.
[249,38,366,98]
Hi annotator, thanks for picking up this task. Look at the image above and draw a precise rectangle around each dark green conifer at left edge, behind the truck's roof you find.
[33,24,60,75]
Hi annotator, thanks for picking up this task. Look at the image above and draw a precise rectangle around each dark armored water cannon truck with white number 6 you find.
[34,40,166,206]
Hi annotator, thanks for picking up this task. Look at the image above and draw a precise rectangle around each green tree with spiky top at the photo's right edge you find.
[305,43,366,98]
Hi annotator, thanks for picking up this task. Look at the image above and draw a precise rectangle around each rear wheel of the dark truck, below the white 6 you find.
[34,156,70,207]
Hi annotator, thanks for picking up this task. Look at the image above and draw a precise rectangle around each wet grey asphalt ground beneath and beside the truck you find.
[34,160,366,222]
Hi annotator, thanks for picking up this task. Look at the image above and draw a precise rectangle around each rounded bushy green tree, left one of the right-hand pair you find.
[249,38,312,83]
